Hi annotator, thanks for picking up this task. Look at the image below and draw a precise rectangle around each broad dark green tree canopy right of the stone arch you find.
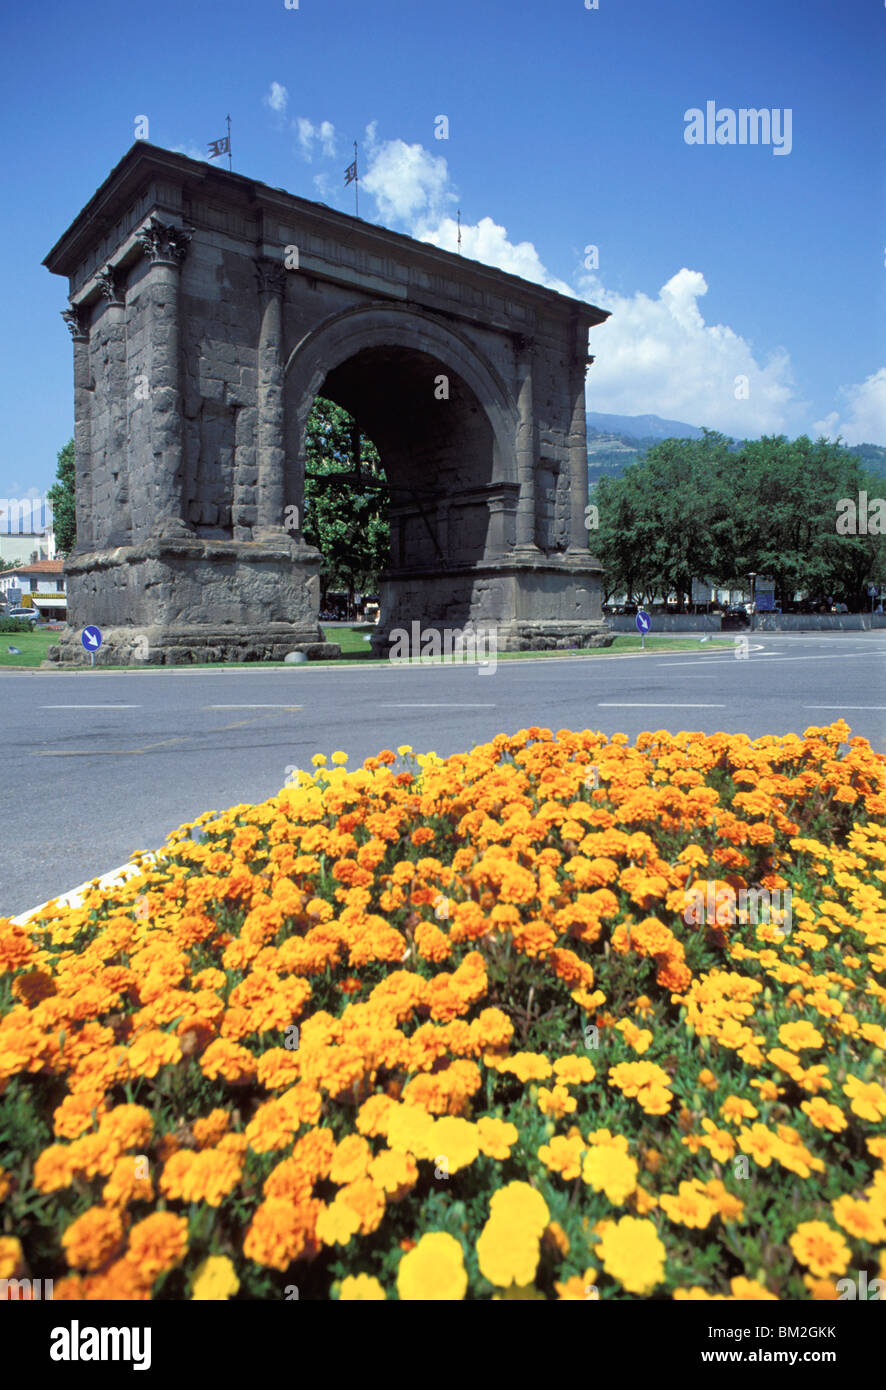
[590,430,886,607]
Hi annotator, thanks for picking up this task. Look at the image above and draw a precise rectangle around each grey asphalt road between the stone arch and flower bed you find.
[0,632,886,916]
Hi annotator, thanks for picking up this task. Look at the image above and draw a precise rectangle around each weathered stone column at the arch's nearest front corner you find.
[139,217,193,538]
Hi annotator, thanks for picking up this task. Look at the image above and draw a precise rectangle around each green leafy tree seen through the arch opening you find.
[302,396,391,602]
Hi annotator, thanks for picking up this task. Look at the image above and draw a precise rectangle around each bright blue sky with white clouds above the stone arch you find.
[0,0,886,496]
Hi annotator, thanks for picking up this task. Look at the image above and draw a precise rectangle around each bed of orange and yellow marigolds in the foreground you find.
[0,723,886,1300]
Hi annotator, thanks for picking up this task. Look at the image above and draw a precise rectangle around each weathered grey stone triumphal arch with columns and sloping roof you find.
[45,142,608,663]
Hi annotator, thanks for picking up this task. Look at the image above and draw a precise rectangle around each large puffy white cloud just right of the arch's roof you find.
[580,267,804,439]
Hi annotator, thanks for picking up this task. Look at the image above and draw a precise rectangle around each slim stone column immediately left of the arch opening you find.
[253,257,286,539]
